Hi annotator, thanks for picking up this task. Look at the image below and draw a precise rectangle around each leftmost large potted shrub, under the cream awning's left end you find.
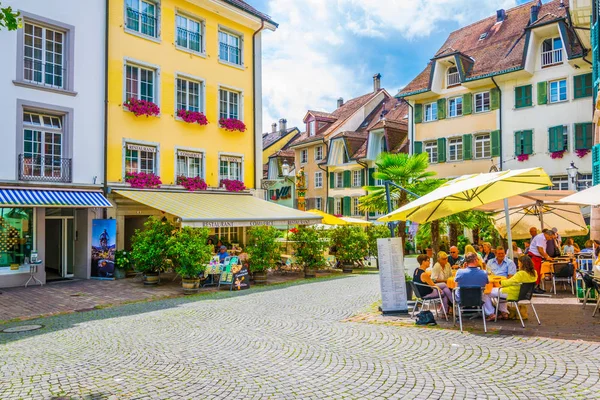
[131,217,175,285]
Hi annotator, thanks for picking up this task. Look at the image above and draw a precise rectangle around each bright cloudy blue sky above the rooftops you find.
[263,0,515,131]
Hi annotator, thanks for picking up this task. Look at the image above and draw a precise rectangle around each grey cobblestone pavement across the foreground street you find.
[0,275,600,399]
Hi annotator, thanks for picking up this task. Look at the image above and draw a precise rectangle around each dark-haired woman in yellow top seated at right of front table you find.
[483,256,537,321]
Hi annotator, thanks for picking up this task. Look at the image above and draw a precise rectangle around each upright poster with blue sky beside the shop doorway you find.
[91,219,117,278]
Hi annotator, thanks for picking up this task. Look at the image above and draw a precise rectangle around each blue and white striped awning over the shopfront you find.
[0,188,112,207]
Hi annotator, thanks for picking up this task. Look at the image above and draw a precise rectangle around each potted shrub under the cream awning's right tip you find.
[292,227,328,278]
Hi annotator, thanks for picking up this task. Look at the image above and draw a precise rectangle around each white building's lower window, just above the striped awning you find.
[19,112,65,181]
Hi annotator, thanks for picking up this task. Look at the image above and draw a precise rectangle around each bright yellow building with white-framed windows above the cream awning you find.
[106,0,284,248]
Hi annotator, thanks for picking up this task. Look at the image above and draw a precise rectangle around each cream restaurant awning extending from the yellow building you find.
[114,190,321,228]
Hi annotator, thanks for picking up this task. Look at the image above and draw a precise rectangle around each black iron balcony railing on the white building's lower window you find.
[19,154,72,182]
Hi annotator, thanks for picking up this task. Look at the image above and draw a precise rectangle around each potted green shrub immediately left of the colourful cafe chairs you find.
[167,226,213,294]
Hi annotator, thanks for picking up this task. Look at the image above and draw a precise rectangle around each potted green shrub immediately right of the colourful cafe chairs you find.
[246,226,281,283]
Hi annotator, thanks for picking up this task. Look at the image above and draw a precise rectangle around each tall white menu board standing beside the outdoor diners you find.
[377,238,408,314]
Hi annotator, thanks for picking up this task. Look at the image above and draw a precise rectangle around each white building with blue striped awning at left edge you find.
[0,0,106,287]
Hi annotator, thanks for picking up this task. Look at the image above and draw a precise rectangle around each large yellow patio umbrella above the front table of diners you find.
[378,168,552,224]
